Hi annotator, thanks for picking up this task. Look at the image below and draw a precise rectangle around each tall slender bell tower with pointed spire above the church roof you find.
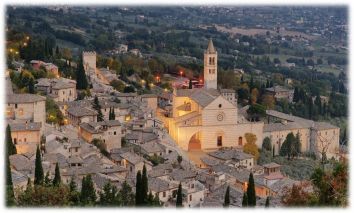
[204,39,218,89]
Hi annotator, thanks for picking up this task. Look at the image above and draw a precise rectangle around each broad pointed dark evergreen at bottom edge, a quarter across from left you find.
[80,175,97,206]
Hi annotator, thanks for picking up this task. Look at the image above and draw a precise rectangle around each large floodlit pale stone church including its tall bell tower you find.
[160,40,264,151]
